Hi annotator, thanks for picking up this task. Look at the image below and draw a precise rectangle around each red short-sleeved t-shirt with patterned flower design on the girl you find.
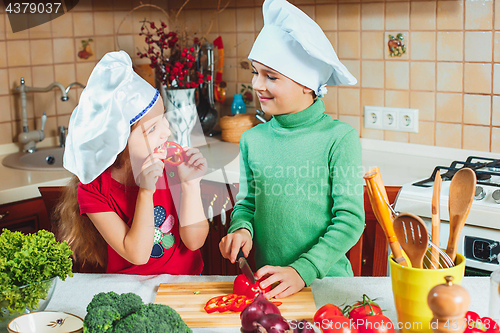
[77,170,203,275]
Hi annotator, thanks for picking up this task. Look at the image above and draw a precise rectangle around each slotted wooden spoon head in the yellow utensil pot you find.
[394,213,429,268]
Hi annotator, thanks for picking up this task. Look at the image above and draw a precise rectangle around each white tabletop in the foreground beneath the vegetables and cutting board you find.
[38,274,490,333]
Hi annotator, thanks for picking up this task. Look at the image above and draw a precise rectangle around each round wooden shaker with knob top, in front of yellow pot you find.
[427,276,470,333]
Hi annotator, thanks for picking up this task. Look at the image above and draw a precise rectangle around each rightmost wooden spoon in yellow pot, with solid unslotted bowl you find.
[446,168,476,262]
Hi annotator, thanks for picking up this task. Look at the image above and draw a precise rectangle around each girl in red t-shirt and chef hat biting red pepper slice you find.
[56,51,209,274]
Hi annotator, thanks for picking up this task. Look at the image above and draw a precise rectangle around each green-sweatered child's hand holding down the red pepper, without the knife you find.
[255,266,306,299]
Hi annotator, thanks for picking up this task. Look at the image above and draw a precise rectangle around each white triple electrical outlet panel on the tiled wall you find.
[364,106,418,133]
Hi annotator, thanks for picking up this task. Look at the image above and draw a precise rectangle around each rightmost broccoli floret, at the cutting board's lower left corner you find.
[138,304,192,333]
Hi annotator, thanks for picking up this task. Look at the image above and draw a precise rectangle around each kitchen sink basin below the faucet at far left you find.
[2,147,65,171]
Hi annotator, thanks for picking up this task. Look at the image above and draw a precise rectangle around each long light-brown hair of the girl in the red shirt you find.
[53,146,129,267]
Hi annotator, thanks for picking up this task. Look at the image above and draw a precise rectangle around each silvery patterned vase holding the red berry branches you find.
[161,85,198,147]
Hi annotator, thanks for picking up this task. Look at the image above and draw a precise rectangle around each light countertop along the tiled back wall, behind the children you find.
[0,137,500,205]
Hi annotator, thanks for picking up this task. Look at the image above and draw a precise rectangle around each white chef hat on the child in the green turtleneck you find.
[248,0,357,97]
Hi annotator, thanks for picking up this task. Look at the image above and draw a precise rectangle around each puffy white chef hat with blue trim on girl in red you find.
[63,51,159,184]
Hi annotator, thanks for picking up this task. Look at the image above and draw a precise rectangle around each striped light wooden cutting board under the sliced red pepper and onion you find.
[155,282,316,328]
